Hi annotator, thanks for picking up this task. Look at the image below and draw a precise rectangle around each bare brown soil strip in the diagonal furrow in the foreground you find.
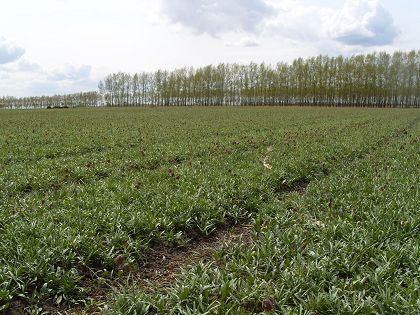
[10,220,252,315]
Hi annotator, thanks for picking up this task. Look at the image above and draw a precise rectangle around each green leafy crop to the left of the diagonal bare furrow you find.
[0,109,413,307]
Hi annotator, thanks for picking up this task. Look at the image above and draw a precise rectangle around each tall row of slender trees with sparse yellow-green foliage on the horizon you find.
[0,51,420,107]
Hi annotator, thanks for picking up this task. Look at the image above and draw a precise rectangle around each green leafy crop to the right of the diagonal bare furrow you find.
[103,117,420,314]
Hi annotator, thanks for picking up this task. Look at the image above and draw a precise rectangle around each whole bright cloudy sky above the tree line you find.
[0,0,420,97]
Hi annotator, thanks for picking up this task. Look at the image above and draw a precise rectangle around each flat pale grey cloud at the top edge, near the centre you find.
[162,0,275,37]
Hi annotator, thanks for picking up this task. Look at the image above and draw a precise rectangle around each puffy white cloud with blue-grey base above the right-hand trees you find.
[327,0,399,46]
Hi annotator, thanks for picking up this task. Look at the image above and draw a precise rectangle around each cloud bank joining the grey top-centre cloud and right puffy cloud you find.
[162,0,399,47]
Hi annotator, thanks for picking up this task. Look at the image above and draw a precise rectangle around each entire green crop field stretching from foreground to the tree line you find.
[0,107,420,314]
